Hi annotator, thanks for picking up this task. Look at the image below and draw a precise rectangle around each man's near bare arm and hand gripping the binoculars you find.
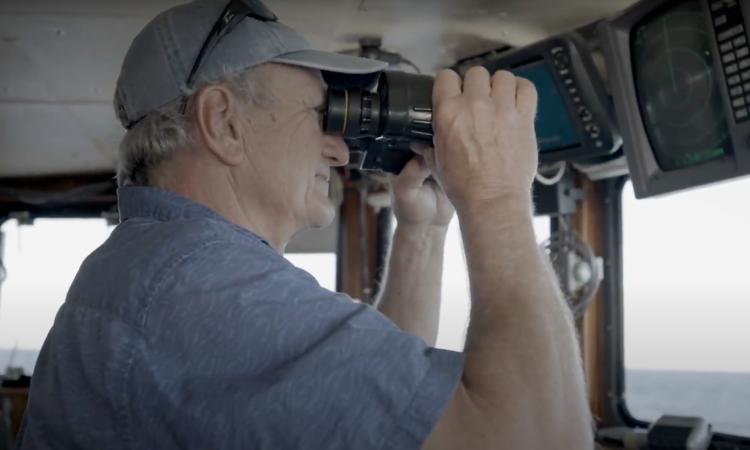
[423,68,594,450]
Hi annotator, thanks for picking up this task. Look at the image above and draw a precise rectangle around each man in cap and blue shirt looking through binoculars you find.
[20,0,592,450]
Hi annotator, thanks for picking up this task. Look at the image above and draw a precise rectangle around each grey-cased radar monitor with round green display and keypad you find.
[599,0,750,198]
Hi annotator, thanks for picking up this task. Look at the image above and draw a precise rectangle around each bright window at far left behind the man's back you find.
[0,219,113,374]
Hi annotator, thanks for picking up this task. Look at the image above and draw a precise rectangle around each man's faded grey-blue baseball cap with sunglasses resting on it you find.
[115,0,388,128]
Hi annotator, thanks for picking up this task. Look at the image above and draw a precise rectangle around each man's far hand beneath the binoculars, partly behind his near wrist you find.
[388,156,455,228]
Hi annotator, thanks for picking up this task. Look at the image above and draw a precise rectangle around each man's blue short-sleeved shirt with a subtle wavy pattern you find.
[18,187,463,450]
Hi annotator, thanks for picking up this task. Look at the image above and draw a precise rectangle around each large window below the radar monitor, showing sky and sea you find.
[622,179,750,435]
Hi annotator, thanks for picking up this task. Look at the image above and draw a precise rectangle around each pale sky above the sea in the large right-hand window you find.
[623,178,750,372]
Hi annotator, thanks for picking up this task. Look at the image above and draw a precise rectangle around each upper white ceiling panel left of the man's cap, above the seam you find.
[0,15,143,104]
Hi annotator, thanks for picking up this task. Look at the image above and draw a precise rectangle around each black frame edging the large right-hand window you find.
[608,176,750,449]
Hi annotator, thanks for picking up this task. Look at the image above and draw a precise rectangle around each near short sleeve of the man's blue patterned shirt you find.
[128,244,463,449]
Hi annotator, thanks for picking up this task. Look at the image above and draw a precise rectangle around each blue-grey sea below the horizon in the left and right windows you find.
[0,349,750,436]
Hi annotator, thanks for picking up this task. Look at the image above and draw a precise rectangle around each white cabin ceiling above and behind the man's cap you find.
[0,0,633,177]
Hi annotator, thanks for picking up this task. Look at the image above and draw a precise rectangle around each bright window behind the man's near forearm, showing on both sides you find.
[436,217,550,351]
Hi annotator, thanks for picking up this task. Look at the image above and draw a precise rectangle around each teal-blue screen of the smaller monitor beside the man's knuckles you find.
[511,59,581,153]
